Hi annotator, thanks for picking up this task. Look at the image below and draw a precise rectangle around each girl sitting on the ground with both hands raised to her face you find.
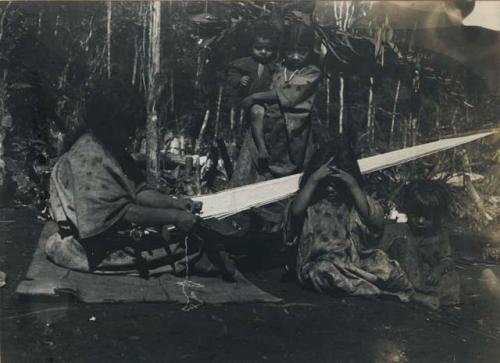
[283,143,414,302]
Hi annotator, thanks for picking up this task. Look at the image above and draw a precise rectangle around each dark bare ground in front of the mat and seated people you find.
[0,208,500,363]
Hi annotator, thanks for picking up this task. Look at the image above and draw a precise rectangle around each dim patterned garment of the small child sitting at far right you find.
[381,223,460,305]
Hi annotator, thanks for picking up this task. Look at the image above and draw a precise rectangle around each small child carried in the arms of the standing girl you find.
[228,24,279,168]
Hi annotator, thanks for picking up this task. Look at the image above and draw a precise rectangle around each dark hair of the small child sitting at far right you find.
[401,180,450,217]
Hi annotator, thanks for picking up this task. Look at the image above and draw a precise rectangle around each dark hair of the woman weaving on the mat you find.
[85,77,146,145]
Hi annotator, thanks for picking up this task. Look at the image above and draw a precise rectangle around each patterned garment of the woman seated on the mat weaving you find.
[44,134,205,273]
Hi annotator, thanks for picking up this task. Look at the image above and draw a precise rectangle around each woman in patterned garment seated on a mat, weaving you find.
[44,79,232,274]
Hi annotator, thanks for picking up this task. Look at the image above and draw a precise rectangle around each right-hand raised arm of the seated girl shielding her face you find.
[332,168,383,230]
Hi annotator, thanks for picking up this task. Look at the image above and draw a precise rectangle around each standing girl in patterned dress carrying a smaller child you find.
[231,23,320,187]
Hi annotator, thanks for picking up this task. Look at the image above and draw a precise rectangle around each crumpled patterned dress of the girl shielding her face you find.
[283,198,414,302]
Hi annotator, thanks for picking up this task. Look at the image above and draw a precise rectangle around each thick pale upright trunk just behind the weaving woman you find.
[146,1,161,186]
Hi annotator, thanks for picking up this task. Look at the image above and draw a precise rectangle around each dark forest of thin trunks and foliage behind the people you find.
[0,0,500,238]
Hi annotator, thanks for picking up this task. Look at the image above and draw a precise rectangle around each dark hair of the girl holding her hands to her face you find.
[300,138,364,201]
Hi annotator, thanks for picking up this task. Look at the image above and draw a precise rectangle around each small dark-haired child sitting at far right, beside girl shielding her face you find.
[382,180,460,308]
